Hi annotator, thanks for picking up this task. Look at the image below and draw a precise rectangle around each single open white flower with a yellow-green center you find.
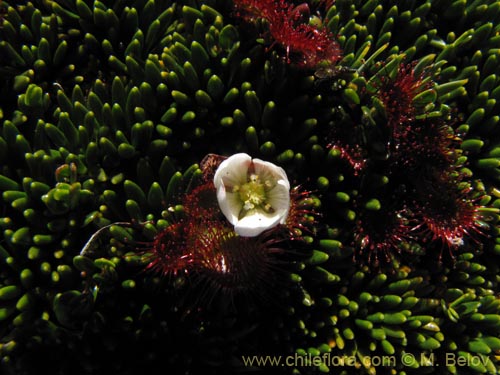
[214,153,290,237]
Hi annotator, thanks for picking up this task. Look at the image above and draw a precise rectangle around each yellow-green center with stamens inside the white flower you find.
[233,173,274,215]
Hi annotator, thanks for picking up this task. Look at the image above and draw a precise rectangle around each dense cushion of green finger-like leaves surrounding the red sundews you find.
[0,0,500,375]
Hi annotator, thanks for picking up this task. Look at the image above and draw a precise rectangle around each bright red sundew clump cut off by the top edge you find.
[234,0,342,68]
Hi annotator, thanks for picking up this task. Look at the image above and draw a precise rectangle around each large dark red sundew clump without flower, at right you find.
[328,62,495,266]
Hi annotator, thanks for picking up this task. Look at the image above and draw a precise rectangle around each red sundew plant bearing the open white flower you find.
[80,153,320,305]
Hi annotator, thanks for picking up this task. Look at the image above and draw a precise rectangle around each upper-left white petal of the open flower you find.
[214,153,252,189]
